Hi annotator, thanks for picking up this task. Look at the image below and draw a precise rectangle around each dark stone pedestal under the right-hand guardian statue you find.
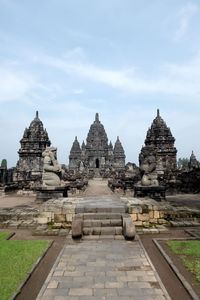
[134,185,166,202]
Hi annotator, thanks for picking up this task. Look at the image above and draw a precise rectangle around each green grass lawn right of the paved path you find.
[167,241,200,283]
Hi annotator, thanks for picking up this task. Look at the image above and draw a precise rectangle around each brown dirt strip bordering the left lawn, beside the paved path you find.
[0,229,66,300]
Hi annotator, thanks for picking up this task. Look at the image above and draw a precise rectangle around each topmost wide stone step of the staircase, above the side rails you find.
[75,205,126,214]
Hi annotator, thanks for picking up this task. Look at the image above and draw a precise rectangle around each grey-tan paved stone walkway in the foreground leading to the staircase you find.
[37,237,170,300]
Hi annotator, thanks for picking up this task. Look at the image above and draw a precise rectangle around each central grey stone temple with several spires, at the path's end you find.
[69,113,125,176]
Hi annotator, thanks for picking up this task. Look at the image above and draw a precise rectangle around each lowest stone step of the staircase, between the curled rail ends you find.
[83,226,122,235]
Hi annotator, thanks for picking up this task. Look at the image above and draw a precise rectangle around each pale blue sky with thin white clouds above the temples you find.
[0,0,200,167]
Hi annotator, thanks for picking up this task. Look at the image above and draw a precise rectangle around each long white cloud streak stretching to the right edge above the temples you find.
[37,51,200,100]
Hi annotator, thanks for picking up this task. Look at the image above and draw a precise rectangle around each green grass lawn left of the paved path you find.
[0,232,50,300]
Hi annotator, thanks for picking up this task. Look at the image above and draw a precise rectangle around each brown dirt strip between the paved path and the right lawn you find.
[140,229,195,300]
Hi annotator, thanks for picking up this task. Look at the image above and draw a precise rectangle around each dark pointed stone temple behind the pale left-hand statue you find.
[16,111,51,180]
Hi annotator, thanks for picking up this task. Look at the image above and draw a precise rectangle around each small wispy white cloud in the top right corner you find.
[174,2,198,41]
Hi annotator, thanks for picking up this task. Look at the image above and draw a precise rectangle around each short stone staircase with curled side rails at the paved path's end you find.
[72,205,135,239]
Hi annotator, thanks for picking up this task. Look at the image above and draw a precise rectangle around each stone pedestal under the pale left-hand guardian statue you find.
[35,186,68,203]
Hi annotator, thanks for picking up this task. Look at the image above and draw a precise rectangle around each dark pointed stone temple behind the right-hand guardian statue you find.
[139,109,177,174]
